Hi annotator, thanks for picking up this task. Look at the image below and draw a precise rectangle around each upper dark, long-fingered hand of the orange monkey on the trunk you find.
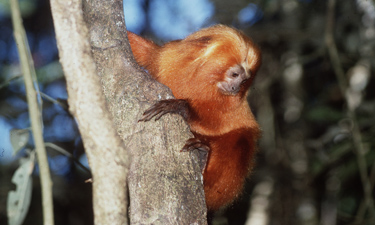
[138,99,190,122]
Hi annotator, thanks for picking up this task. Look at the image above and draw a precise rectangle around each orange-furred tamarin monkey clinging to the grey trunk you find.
[127,25,261,211]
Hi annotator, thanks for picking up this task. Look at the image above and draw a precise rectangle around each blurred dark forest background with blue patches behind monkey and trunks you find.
[0,0,375,225]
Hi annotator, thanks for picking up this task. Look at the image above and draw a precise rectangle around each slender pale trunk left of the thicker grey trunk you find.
[51,0,129,224]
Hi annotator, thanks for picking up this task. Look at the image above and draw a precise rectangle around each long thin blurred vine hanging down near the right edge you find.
[325,0,375,219]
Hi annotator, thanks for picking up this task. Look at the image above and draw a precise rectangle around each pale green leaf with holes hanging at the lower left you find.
[7,151,35,225]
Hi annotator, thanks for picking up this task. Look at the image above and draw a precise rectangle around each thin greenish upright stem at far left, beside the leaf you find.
[10,0,54,225]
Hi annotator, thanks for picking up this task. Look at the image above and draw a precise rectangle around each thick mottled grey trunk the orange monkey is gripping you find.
[83,0,206,224]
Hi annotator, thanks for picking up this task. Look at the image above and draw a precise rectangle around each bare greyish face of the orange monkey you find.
[217,65,251,95]
